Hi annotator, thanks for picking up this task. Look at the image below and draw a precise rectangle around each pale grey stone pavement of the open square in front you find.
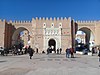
[0,54,100,75]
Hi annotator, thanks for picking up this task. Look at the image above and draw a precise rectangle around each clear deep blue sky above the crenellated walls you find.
[0,0,100,20]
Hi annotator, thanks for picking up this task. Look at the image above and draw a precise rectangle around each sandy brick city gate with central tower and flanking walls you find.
[0,17,100,53]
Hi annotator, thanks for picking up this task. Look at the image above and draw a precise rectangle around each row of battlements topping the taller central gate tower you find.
[32,17,71,21]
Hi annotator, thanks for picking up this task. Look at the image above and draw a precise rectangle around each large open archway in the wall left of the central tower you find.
[11,27,30,46]
